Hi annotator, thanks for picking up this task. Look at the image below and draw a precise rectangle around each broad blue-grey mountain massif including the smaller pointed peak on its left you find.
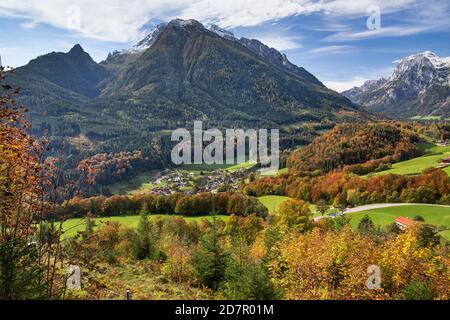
[10,20,367,162]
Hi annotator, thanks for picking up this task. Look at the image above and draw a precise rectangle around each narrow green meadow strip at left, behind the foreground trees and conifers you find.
[63,215,228,238]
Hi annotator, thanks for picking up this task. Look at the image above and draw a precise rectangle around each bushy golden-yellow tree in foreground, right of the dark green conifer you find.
[269,227,383,299]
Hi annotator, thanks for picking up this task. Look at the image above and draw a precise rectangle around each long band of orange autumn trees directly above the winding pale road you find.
[245,169,450,207]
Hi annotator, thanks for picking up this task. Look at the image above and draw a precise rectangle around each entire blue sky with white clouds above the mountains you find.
[0,0,450,91]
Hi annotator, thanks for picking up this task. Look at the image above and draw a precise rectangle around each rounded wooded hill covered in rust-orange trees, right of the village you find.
[288,122,419,173]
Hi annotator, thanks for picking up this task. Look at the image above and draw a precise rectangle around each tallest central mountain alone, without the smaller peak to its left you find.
[102,20,358,126]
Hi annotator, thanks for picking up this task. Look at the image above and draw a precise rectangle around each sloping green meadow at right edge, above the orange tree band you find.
[375,143,450,175]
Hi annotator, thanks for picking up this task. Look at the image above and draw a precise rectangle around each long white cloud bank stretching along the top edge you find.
[0,0,426,42]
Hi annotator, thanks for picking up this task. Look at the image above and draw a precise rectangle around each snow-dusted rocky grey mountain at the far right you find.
[343,51,450,117]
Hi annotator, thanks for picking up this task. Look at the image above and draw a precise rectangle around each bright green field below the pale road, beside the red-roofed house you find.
[348,205,450,239]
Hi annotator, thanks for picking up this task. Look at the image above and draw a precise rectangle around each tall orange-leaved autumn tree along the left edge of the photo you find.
[0,67,61,299]
